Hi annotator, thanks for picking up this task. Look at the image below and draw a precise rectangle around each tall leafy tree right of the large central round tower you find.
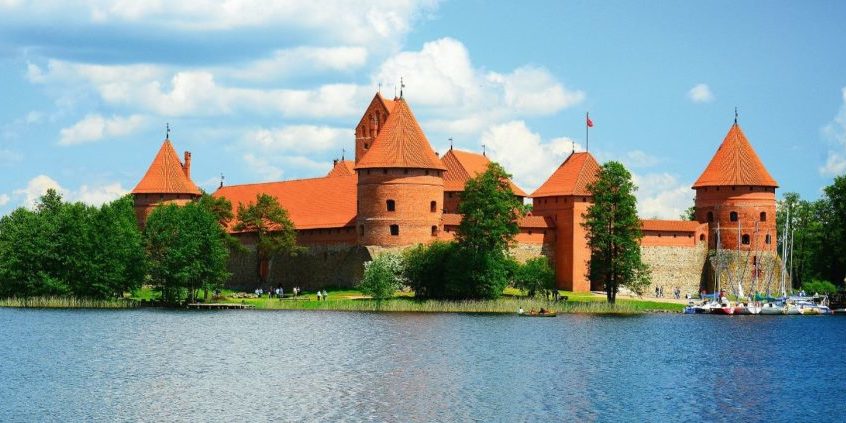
[450,162,525,298]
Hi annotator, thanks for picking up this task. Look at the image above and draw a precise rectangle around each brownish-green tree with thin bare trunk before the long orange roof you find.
[235,194,299,286]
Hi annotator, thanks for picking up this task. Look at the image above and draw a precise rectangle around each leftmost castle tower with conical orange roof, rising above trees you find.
[132,139,201,228]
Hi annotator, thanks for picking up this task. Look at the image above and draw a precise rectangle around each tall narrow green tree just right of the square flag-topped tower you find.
[583,161,648,304]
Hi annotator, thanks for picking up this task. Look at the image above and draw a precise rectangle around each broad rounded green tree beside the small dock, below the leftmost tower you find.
[144,203,229,302]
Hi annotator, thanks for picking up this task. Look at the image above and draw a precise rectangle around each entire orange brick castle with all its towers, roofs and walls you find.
[132,93,777,293]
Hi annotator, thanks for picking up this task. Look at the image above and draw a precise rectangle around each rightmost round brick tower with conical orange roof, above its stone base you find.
[693,122,778,252]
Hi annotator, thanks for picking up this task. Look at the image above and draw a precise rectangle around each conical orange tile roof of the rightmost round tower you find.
[693,123,778,189]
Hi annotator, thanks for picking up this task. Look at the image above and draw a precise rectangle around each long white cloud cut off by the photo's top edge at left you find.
[8,0,438,49]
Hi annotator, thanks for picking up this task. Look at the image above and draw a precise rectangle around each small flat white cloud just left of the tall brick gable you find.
[244,125,354,153]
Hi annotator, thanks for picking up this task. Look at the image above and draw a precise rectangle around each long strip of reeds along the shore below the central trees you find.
[235,298,647,315]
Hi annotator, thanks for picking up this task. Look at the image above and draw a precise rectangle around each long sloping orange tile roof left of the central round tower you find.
[212,176,358,231]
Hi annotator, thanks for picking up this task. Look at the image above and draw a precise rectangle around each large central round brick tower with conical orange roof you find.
[355,94,446,247]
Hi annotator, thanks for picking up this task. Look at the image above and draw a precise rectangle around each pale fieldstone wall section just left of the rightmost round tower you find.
[640,242,708,297]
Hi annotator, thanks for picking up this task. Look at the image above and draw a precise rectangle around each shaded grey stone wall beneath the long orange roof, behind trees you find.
[226,245,370,291]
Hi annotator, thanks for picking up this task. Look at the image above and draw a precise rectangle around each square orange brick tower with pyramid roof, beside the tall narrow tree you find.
[530,152,601,292]
